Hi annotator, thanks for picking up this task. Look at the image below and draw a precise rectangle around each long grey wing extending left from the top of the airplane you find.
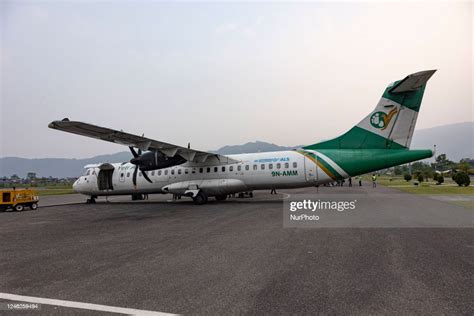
[48,118,238,164]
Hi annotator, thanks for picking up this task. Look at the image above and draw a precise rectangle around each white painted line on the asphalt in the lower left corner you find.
[0,293,176,315]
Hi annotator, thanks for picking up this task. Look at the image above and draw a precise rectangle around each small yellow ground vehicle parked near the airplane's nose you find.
[0,188,39,212]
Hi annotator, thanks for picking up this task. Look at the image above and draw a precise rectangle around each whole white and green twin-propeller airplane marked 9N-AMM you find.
[49,70,435,204]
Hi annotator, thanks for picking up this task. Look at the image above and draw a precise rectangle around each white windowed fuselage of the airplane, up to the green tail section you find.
[73,151,334,196]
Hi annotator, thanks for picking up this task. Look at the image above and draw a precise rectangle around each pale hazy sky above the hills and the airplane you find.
[0,1,474,158]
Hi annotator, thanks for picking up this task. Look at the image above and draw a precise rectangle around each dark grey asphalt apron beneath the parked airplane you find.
[0,187,474,315]
